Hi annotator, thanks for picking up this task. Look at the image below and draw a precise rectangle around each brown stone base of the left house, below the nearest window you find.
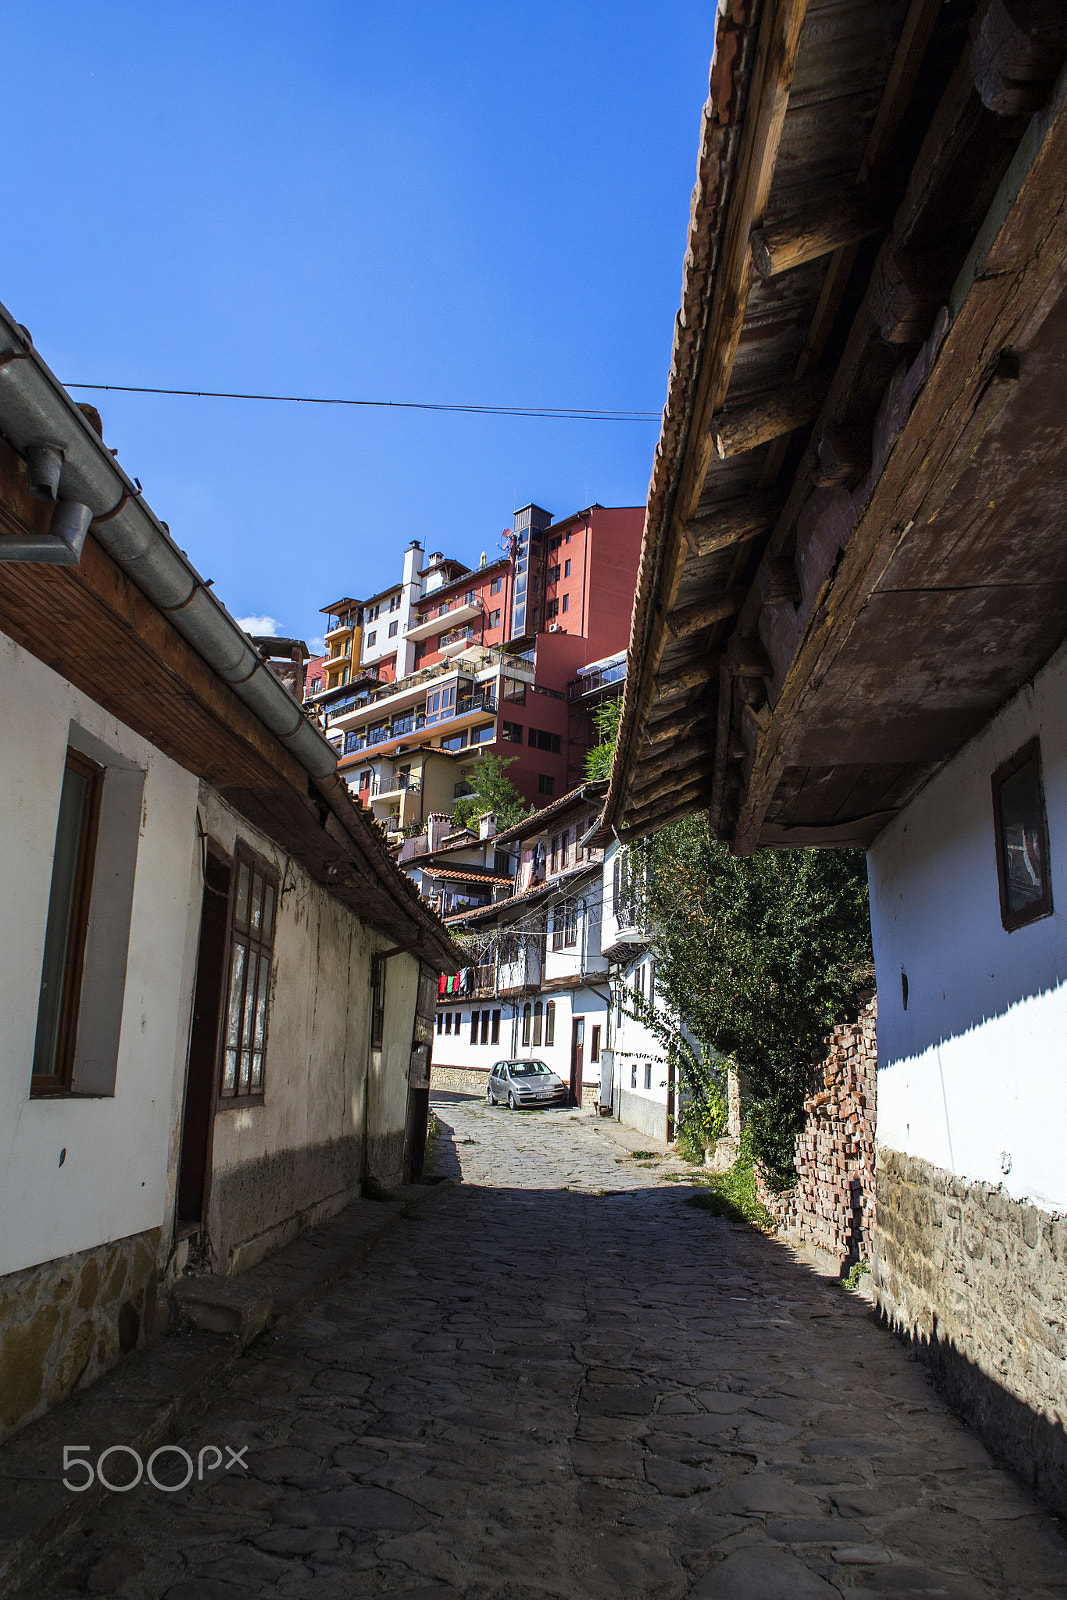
[0,1227,160,1438]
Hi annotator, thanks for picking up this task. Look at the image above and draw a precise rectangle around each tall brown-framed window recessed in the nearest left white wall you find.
[30,750,104,1094]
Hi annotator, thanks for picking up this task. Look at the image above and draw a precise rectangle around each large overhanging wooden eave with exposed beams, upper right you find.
[600,0,1067,851]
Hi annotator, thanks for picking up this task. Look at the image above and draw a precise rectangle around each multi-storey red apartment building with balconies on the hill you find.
[309,506,645,829]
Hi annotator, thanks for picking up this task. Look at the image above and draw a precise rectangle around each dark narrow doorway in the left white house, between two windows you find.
[178,850,230,1222]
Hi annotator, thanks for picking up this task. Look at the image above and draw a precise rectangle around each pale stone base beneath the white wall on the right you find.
[872,1147,1067,1515]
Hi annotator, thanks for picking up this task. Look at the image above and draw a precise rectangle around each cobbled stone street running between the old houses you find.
[26,1096,1067,1600]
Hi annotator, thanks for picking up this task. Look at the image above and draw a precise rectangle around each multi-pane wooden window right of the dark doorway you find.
[221,850,278,1099]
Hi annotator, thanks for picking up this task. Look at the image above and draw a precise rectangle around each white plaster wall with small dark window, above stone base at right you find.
[869,636,1067,1211]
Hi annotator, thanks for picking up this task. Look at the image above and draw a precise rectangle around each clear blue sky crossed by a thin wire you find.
[8,0,713,638]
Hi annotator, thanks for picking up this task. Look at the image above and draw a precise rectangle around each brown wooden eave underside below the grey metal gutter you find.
[0,438,461,971]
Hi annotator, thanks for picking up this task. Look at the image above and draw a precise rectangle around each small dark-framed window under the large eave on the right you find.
[993,739,1053,933]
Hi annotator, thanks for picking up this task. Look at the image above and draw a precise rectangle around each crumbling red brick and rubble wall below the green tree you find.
[757,998,878,1272]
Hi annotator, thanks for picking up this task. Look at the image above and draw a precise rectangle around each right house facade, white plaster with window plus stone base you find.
[869,646,1067,1496]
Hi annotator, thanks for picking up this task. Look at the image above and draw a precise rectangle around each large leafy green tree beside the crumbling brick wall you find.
[637,816,873,1187]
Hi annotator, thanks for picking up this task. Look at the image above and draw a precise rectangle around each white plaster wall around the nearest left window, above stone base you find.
[0,635,198,1274]
